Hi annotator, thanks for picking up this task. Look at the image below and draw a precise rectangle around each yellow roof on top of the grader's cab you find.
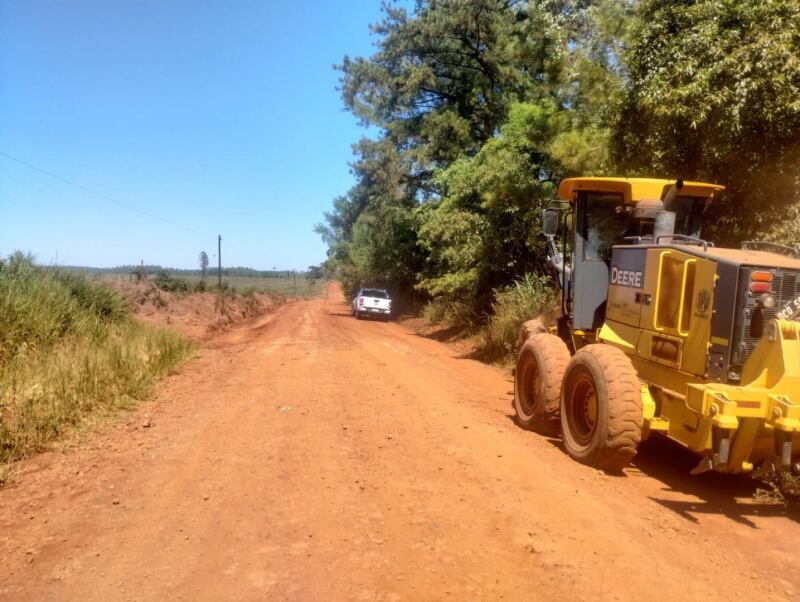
[558,178,725,203]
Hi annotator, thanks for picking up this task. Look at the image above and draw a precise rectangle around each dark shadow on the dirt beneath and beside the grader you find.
[507,413,800,529]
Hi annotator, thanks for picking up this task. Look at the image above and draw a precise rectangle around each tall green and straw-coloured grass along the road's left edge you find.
[0,253,191,464]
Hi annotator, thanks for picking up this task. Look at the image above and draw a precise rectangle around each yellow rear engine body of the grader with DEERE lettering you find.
[598,244,800,472]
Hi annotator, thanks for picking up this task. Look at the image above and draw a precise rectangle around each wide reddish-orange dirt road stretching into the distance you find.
[0,285,800,601]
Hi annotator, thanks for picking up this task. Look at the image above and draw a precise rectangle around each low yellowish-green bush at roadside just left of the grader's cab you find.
[478,274,557,358]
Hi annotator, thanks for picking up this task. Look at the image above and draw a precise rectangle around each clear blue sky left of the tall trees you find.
[0,0,380,269]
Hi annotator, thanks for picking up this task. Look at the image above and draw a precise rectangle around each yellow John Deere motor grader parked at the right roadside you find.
[514,177,800,473]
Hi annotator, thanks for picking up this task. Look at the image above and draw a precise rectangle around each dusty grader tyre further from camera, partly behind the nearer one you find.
[514,333,569,436]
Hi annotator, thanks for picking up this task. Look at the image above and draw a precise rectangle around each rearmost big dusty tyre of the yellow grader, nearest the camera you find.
[561,343,642,471]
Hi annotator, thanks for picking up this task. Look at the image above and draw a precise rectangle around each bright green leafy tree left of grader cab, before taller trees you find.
[417,102,562,321]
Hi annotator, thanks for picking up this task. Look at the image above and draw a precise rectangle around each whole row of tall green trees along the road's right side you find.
[317,0,800,342]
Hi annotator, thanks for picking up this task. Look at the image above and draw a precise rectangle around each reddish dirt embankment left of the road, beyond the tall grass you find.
[104,282,287,340]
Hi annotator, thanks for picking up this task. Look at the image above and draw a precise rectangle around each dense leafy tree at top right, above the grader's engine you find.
[613,0,800,244]
